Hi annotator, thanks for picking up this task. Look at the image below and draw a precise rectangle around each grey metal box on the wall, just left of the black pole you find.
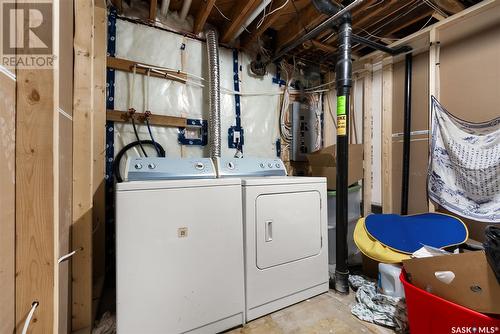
[290,102,321,161]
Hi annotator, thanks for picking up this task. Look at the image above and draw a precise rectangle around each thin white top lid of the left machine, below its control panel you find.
[116,178,241,191]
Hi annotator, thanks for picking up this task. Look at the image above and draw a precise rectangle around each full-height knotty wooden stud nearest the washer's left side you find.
[72,0,107,332]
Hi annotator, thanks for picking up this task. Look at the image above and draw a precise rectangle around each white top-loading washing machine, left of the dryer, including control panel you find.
[116,158,245,334]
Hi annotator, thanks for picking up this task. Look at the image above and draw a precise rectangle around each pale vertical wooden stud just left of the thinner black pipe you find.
[382,58,392,213]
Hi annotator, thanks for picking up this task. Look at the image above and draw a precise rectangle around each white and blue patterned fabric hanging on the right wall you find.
[428,97,500,223]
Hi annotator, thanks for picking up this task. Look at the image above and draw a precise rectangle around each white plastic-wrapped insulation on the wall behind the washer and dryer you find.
[115,20,282,166]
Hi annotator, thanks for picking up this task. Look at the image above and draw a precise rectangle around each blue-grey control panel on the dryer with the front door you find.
[215,158,287,177]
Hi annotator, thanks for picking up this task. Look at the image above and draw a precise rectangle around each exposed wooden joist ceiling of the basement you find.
[113,0,480,66]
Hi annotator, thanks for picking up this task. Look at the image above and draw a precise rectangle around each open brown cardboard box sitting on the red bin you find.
[403,251,500,314]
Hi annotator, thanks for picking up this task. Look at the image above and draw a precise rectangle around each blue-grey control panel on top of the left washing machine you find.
[125,157,217,181]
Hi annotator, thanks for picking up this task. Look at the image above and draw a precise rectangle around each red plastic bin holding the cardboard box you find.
[399,270,500,334]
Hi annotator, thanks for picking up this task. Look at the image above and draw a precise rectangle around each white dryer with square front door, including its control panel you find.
[217,158,329,321]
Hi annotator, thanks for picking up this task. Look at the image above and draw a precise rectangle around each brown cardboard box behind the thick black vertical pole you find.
[307,144,363,190]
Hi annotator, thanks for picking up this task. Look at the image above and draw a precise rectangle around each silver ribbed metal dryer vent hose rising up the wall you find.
[205,29,221,158]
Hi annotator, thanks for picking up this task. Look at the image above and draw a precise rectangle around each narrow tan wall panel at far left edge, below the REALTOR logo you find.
[0,73,16,334]
